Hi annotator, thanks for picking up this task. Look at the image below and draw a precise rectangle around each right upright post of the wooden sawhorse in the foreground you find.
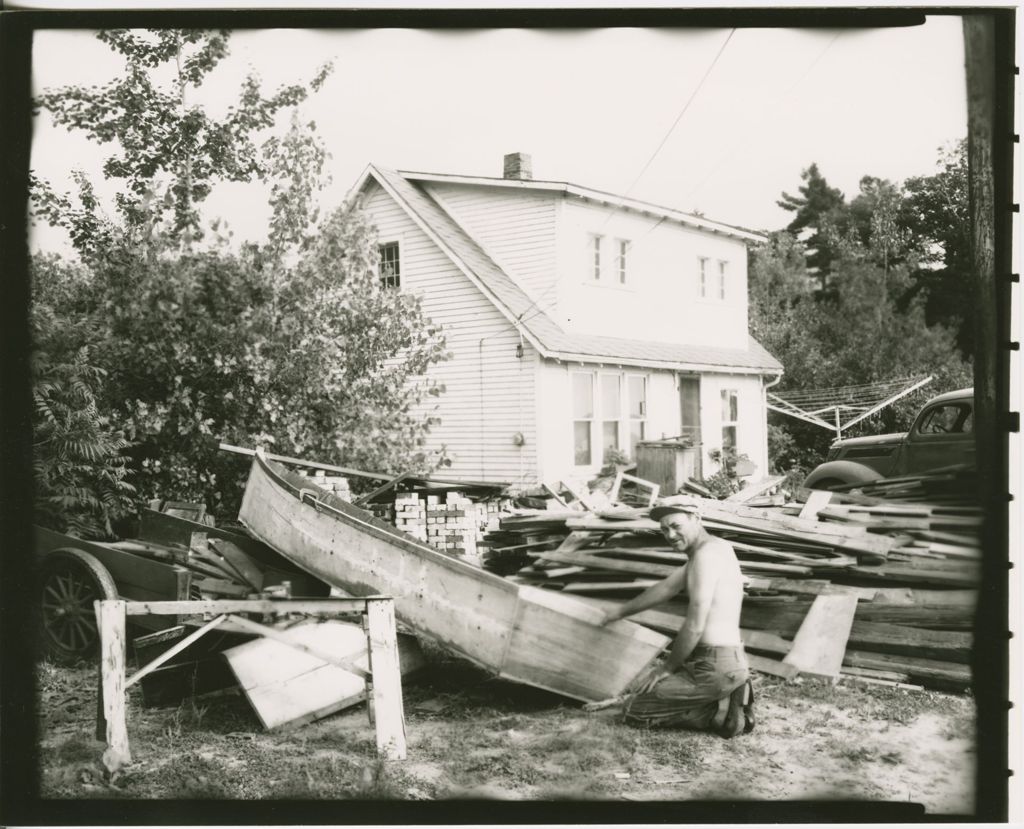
[367,599,406,759]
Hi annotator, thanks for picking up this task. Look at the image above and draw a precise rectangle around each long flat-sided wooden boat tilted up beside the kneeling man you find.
[239,455,669,701]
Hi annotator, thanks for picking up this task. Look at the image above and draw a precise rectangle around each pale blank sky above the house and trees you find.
[25,16,967,249]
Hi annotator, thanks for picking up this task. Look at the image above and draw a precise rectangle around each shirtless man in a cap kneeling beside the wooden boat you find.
[603,496,754,737]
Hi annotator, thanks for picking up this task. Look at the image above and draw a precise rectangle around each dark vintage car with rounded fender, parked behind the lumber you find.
[804,389,975,489]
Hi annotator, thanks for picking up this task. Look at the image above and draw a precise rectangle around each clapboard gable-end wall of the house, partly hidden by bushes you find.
[364,178,538,481]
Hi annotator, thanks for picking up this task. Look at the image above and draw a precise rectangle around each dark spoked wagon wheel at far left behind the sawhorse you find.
[41,550,118,664]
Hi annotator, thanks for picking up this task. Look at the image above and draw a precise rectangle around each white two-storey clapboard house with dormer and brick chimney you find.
[353,154,782,482]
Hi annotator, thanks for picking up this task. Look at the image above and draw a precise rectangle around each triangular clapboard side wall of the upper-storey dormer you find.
[424,182,560,299]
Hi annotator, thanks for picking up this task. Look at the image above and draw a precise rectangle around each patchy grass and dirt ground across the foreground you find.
[38,658,975,815]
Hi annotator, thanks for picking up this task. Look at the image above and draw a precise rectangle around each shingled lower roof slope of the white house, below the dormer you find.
[353,165,782,374]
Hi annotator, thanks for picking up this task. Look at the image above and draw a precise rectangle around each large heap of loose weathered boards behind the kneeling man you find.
[484,471,983,691]
